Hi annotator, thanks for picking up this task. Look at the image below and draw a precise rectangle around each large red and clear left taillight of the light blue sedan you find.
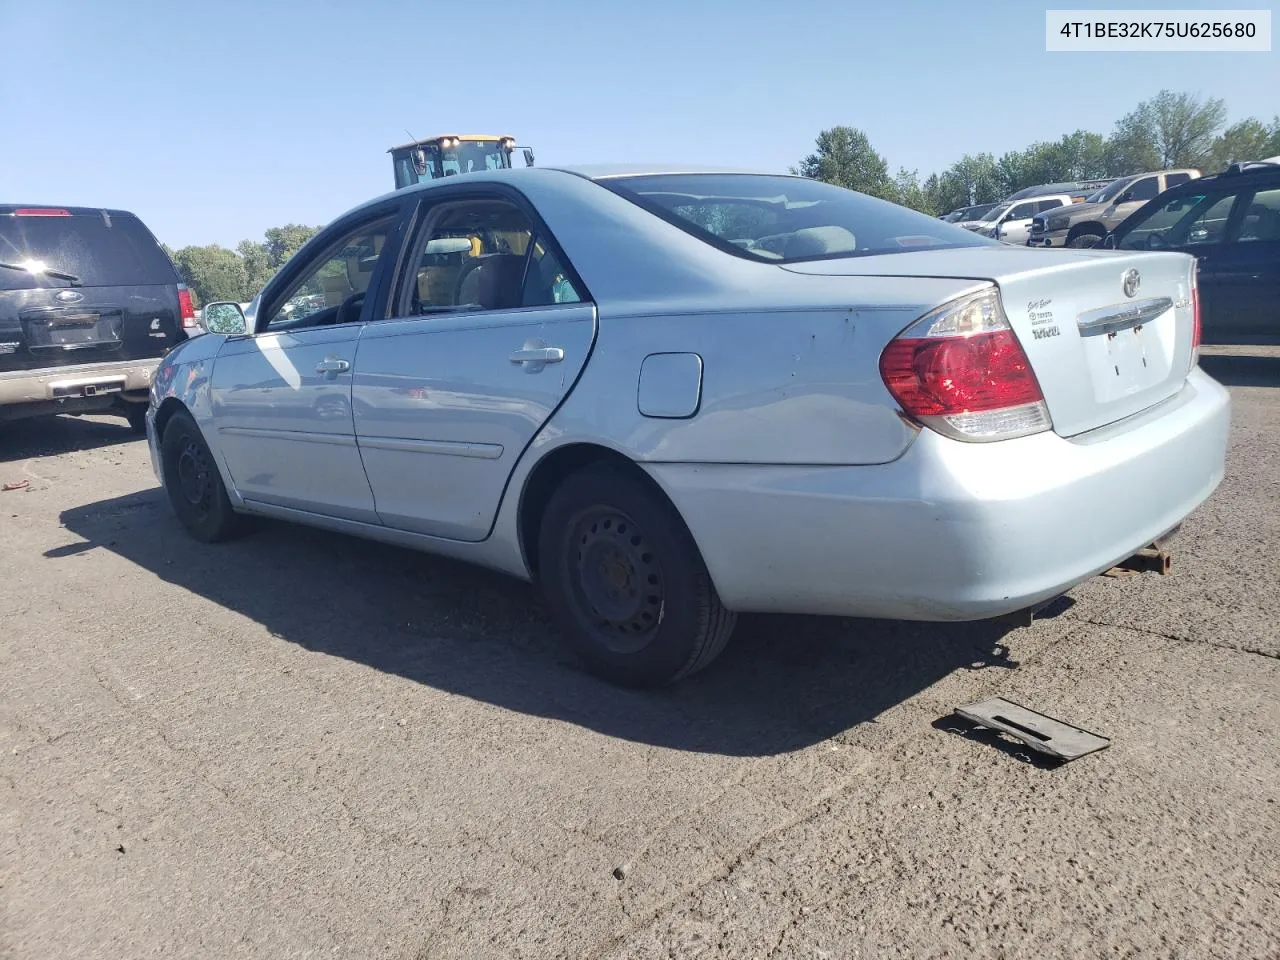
[879,287,1052,440]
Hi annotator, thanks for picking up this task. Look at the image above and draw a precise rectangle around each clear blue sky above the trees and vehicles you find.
[0,0,1280,247]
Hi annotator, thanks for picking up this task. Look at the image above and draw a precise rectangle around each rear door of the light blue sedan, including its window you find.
[352,187,595,541]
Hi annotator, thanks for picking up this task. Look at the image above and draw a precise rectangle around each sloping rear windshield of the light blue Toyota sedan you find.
[599,173,993,264]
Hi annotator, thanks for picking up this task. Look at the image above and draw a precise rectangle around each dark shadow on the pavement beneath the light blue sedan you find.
[57,489,1039,756]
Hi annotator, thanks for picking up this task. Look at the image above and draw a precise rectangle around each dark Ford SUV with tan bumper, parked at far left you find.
[0,205,198,433]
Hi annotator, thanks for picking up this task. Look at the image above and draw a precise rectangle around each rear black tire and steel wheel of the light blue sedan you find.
[538,465,737,687]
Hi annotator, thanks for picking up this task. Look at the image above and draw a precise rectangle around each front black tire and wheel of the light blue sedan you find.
[160,412,247,543]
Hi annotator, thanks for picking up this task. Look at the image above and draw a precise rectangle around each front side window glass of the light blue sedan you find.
[266,215,397,330]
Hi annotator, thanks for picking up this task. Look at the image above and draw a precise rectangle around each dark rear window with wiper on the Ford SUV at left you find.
[0,212,178,291]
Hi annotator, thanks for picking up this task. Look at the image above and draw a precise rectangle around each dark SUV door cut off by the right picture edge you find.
[1213,184,1280,343]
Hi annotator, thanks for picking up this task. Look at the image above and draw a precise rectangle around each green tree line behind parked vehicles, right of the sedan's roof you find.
[791,90,1280,216]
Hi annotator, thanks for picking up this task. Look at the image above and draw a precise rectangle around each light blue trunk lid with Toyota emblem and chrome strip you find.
[786,247,1196,436]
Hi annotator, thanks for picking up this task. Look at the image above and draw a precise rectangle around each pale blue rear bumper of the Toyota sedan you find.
[645,369,1230,621]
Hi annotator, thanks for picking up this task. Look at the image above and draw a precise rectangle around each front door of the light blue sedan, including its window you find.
[211,202,401,522]
